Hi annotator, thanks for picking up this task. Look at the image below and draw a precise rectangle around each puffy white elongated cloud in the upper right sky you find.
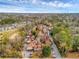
[41,1,74,8]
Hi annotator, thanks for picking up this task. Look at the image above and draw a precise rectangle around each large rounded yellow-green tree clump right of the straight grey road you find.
[51,22,72,55]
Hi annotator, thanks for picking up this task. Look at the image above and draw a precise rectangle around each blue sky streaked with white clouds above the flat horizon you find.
[0,0,79,13]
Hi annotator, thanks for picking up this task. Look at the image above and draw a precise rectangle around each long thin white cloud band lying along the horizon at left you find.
[0,8,50,13]
